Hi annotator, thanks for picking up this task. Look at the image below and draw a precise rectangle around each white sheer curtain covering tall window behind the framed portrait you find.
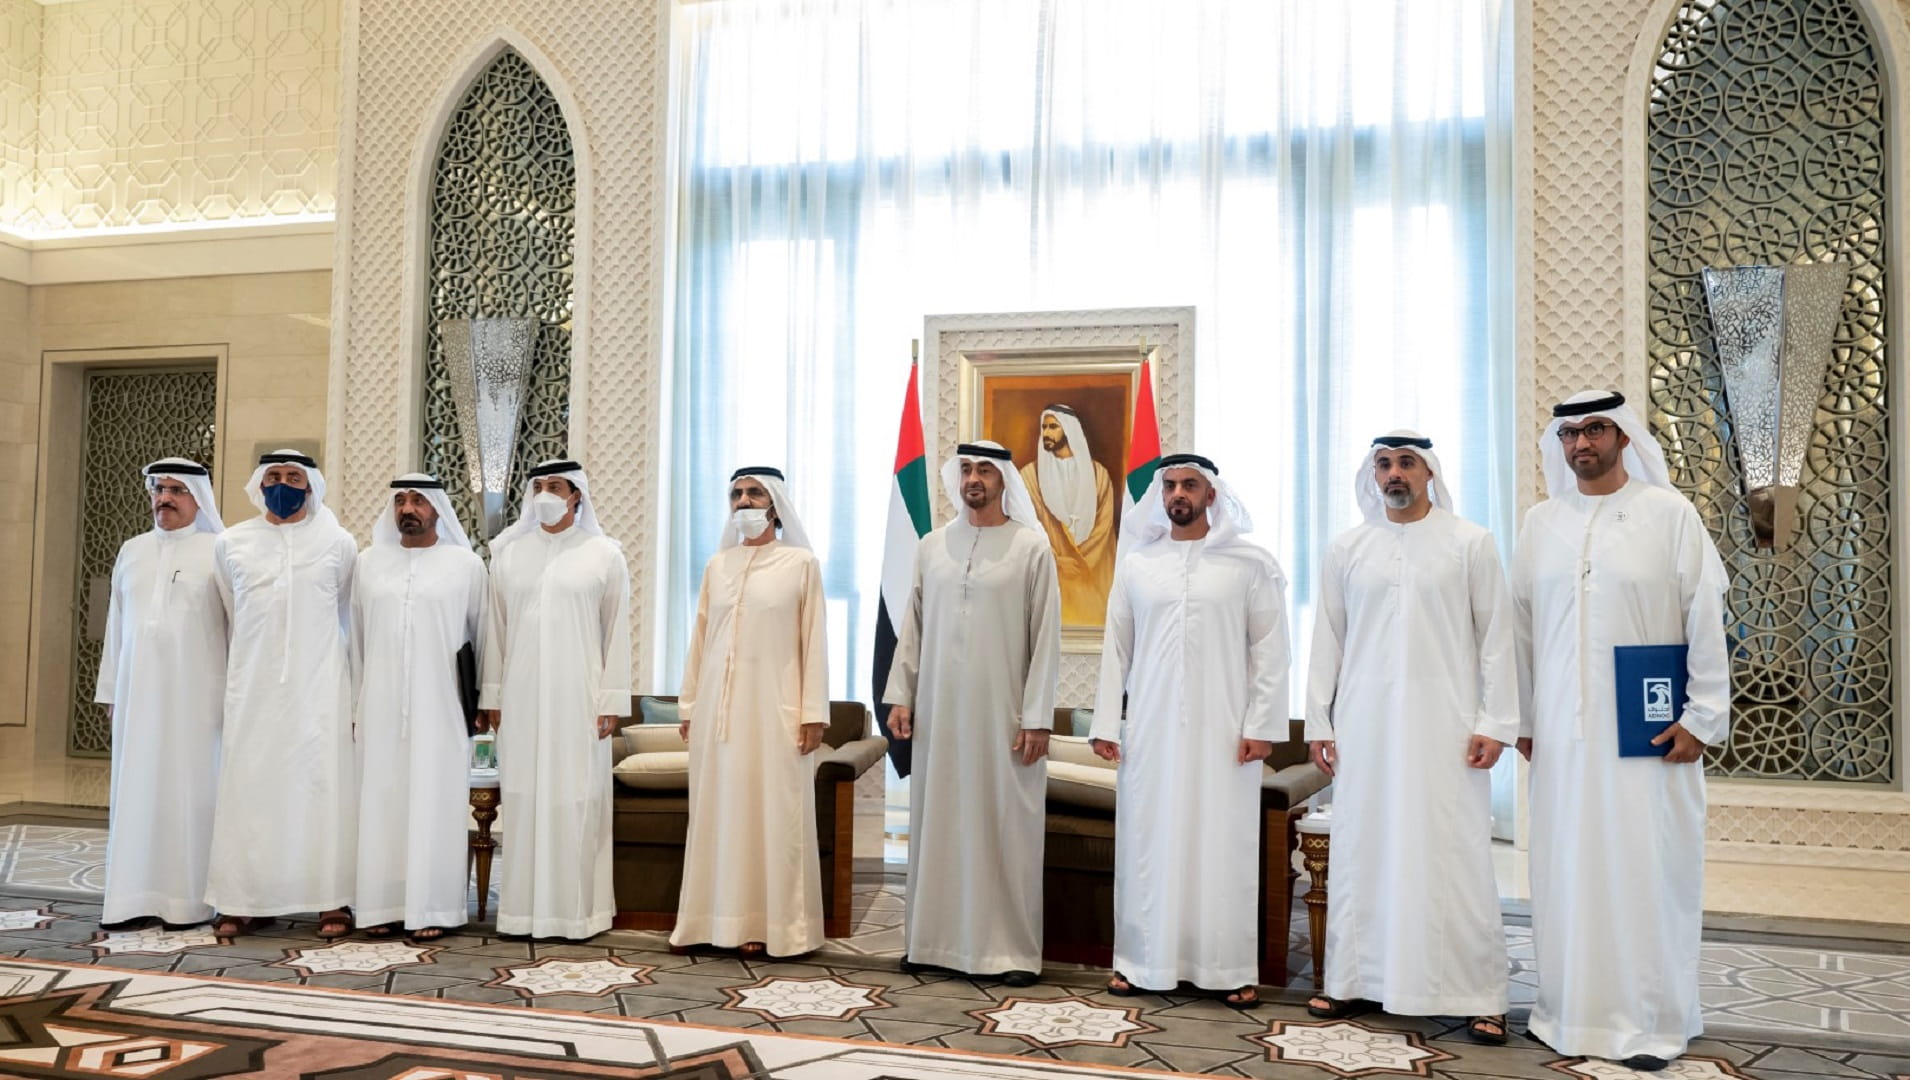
[659,0,1513,698]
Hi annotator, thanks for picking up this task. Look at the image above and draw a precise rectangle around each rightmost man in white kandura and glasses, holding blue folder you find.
[1513,390,1730,1070]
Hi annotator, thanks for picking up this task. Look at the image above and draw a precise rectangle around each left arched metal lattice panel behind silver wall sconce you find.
[422,50,577,537]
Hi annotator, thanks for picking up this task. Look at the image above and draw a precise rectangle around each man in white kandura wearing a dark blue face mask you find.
[206,449,357,939]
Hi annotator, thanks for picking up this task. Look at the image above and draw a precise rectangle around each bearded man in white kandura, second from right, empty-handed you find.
[1306,430,1518,1044]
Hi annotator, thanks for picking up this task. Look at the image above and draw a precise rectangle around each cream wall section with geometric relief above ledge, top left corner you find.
[8,0,338,235]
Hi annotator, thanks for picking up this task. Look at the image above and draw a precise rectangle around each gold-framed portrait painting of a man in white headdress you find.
[955,338,1159,654]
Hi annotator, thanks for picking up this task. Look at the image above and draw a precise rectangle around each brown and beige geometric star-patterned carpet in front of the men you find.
[0,889,1910,1080]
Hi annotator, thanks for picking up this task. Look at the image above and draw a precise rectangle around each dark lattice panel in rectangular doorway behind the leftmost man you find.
[67,367,218,757]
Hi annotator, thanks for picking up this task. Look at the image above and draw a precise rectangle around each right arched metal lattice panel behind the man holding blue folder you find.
[1646,0,1897,784]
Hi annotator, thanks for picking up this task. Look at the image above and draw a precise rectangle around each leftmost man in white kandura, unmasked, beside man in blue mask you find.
[94,457,227,927]
